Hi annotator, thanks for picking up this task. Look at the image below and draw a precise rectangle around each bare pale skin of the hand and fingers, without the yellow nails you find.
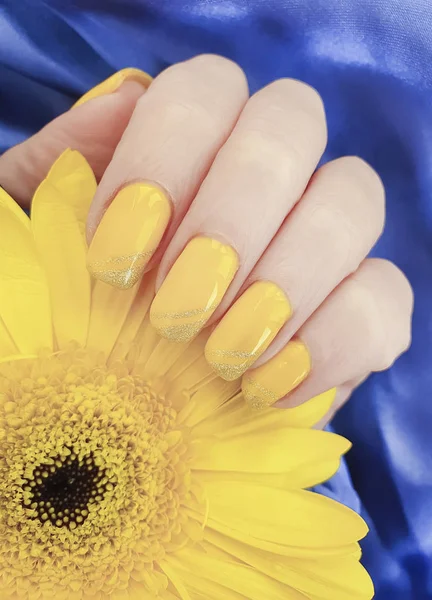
[0,55,413,417]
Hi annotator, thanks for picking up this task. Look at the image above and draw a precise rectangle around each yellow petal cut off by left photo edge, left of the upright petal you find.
[0,203,52,354]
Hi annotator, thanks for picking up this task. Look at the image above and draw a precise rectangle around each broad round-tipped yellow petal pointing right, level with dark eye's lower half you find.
[205,481,367,548]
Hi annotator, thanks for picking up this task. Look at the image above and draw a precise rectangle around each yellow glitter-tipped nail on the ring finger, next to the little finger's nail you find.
[205,281,291,381]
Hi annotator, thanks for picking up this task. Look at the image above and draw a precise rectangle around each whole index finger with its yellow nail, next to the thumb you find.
[88,56,248,288]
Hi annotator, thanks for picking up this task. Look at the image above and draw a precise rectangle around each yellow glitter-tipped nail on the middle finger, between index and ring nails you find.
[150,237,238,342]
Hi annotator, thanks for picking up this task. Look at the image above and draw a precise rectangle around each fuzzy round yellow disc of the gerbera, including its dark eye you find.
[0,348,196,600]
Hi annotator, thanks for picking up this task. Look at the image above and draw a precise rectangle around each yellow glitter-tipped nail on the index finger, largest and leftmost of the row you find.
[87,183,171,289]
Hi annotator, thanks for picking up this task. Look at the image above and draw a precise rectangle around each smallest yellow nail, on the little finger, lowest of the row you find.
[242,340,311,409]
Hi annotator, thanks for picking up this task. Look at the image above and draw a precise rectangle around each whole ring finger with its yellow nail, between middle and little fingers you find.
[206,157,384,379]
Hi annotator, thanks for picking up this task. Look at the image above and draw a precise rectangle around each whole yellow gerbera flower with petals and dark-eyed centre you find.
[0,151,373,600]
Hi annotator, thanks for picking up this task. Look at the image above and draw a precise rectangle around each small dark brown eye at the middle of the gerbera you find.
[22,448,114,529]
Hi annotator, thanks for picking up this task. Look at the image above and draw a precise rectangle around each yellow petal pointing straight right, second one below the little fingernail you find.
[192,428,350,473]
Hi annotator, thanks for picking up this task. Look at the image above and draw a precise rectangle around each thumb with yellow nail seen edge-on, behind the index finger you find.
[0,69,150,207]
